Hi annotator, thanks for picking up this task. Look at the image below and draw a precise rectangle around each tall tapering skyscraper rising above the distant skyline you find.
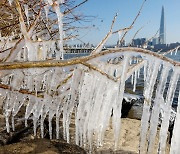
[159,7,166,44]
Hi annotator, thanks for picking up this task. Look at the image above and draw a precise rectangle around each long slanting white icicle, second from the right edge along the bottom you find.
[159,68,179,153]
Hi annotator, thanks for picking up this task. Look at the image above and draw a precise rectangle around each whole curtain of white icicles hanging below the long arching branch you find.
[0,51,180,153]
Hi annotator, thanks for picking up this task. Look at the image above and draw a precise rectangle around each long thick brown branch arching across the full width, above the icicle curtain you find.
[0,47,180,70]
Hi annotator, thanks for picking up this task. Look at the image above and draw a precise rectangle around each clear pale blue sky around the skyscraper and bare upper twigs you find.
[73,0,180,44]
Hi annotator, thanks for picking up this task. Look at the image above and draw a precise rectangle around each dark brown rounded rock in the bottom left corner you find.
[0,139,86,154]
